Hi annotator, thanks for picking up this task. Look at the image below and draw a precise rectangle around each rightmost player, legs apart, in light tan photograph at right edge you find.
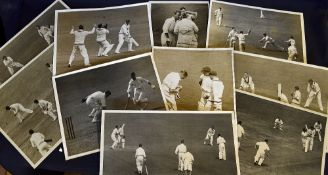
[304,79,323,111]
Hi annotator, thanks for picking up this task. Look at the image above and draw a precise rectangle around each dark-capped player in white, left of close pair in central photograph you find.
[198,66,212,111]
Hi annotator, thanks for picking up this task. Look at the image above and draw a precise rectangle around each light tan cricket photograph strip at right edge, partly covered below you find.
[234,51,328,114]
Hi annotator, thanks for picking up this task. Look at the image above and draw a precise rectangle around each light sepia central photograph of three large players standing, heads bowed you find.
[153,47,235,111]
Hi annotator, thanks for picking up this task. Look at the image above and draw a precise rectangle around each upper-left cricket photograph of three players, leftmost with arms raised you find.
[54,3,153,75]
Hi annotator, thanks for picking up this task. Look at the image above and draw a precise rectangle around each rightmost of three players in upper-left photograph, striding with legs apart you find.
[115,20,139,53]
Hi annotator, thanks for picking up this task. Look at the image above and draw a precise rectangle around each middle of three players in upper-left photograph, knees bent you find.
[96,24,114,57]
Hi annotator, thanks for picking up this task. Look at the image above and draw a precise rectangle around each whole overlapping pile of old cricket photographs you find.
[0,0,328,175]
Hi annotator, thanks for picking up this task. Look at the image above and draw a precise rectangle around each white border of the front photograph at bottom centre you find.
[99,110,240,175]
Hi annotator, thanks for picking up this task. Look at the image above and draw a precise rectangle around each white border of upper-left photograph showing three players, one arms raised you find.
[52,2,154,76]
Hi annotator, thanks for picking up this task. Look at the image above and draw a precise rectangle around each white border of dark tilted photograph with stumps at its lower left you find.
[52,52,165,160]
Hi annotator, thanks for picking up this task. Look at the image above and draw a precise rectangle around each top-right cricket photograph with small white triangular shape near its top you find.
[207,0,307,63]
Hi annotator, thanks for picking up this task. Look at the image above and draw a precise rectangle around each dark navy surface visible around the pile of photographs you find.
[0,0,328,175]
